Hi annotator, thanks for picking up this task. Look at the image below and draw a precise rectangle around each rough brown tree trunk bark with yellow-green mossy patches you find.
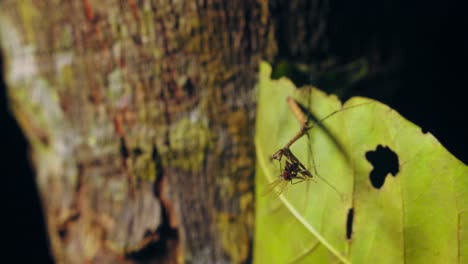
[0,0,275,263]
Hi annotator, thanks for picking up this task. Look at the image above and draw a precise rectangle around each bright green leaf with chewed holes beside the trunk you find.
[254,60,468,263]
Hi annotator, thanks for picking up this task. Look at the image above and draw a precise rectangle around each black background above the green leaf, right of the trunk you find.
[271,0,468,164]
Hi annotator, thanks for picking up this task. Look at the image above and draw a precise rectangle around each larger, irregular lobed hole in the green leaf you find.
[366,145,400,189]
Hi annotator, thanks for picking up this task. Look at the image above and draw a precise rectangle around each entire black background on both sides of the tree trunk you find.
[0,0,468,263]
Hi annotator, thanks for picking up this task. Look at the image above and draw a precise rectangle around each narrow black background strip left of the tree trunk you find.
[0,54,52,263]
